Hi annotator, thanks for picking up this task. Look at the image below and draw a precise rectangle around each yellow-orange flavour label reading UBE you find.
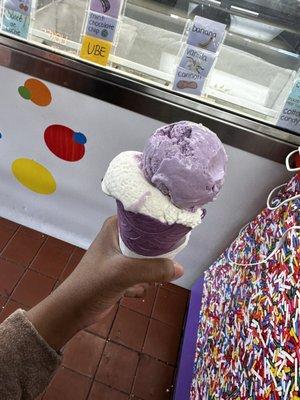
[80,35,112,65]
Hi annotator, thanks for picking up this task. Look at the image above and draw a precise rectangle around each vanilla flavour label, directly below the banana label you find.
[179,46,216,77]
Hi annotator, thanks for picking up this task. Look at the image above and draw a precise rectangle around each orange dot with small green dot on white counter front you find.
[18,78,52,107]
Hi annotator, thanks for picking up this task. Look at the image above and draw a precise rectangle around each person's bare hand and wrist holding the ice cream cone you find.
[28,217,183,349]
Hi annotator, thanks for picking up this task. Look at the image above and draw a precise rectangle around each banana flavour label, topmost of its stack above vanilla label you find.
[187,16,226,53]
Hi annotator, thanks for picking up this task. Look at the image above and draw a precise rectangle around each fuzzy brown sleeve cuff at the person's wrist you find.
[0,310,61,400]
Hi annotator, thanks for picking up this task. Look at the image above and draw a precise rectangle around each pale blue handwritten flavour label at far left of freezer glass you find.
[2,9,30,39]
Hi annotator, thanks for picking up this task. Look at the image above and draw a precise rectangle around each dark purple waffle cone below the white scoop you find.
[117,200,191,257]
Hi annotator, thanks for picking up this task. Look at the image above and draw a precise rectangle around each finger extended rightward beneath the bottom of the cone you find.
[122,258,184,285]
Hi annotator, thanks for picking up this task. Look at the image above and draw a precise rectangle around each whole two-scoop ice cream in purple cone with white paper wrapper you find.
[102,121,227,258]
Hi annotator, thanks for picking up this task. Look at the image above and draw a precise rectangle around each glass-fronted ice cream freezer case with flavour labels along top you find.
[1,0,300,133]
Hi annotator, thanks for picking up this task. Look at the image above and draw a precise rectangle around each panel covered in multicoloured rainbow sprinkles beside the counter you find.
[190,176,300,400]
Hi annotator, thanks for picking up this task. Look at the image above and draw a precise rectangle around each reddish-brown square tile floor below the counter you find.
[0,218,189,400]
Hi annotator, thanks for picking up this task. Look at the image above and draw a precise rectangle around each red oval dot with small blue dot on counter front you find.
[44,125,87,161]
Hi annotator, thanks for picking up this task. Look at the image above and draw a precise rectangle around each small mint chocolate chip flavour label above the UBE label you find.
[86,11,118,42]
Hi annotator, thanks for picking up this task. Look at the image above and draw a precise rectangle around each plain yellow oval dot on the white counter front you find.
[11,158,56,194]
